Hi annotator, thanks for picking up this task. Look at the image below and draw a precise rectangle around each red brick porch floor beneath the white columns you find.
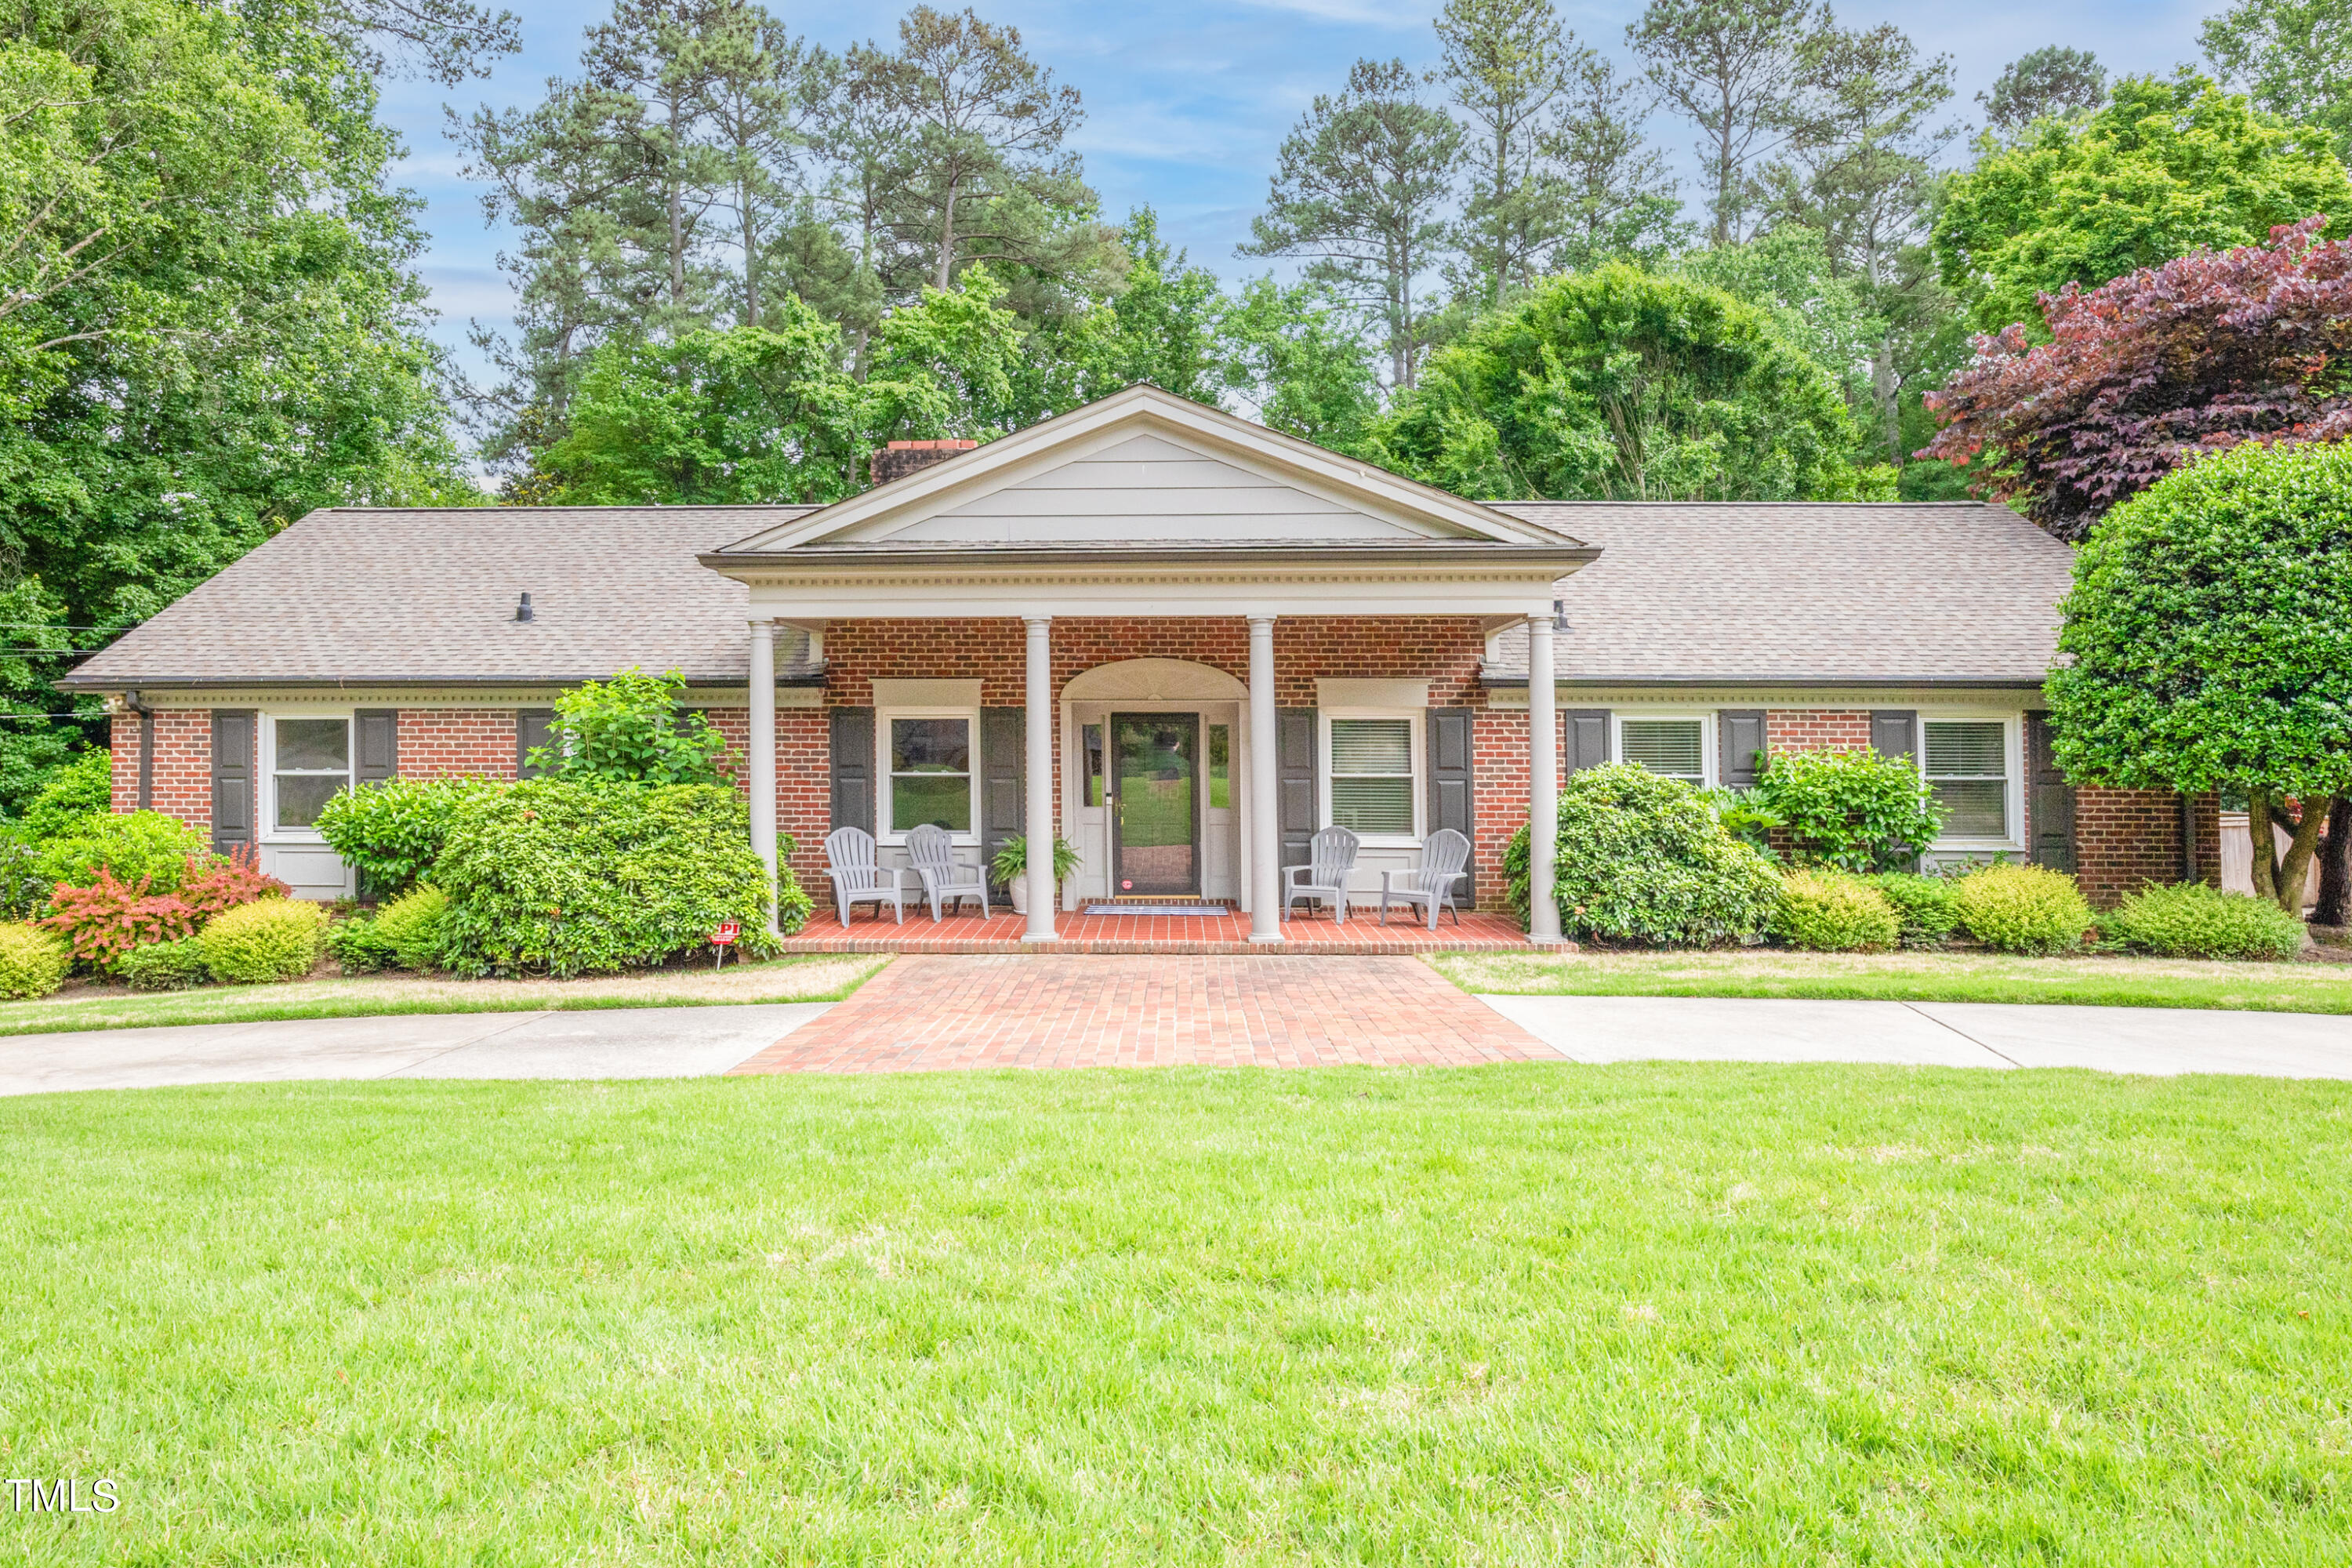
[783,905,1526,956]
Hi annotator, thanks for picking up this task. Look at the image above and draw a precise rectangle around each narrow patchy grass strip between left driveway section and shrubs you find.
[0,954,889,1034]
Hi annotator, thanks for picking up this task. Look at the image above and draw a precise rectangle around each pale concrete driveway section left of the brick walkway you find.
[0,1001,835,1095]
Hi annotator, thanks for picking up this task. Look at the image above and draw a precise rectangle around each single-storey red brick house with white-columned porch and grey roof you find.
[64,386,2218,940]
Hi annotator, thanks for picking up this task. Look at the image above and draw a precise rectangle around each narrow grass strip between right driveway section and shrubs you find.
[1430,949,2352,1013]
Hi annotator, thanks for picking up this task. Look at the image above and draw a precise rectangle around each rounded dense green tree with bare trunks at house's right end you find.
[2046,442,2352,912]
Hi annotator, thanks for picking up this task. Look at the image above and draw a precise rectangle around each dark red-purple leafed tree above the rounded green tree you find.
[1917,214,2352,539]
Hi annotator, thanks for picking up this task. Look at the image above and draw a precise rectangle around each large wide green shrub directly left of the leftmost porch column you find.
[433,779,776,975]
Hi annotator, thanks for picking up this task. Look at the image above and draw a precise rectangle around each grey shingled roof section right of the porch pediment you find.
[1489,501,2074,687]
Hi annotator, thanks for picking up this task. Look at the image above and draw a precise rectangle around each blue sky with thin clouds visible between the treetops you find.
[383,0,2223,390]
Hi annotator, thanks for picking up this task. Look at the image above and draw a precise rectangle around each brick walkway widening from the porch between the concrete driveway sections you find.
[736,954,1557,1072]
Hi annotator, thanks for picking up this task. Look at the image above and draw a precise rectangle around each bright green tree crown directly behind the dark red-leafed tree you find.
[1933,68,2352,332]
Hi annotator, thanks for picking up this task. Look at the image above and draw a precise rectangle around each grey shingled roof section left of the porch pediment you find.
[59,506,828,691]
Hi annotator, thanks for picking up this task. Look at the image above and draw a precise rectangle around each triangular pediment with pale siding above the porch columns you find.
[724,386,1564,555]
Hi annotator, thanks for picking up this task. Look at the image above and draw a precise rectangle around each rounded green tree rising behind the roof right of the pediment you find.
[1374,263,1858,501]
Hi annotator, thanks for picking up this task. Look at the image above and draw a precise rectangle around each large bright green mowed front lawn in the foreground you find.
[0,1065,2352,1566]
